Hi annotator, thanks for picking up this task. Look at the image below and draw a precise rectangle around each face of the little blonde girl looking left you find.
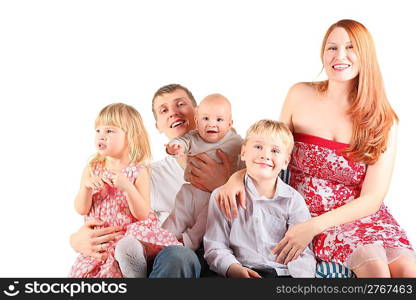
[95,125,128,158]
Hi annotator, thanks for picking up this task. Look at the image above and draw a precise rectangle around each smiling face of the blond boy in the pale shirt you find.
[241,135,290,181]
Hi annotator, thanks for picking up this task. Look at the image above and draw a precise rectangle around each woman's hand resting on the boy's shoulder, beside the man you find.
[215,169,246,220]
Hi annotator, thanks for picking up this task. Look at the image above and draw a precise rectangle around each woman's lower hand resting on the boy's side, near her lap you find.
[272,220,316,265]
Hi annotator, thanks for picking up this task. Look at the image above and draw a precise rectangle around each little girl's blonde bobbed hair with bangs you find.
[90,103,152,165]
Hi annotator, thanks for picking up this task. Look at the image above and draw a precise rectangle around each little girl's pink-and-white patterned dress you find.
[69,165,182,278]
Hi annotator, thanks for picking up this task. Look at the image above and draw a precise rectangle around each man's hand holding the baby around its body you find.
[187,149,231,192]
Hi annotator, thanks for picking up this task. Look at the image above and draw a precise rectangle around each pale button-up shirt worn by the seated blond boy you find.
[204,175,316,277]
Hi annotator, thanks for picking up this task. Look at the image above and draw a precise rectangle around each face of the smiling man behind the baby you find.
[153,89,195,139]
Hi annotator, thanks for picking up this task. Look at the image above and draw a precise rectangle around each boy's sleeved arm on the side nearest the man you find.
[204,190,239,277]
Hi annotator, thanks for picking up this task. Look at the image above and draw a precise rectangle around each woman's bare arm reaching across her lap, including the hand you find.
[274,125,397,263]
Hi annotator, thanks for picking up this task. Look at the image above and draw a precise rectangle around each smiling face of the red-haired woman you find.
[323,27,360,82]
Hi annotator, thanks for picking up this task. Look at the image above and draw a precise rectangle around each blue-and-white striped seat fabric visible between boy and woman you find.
[279,170,356,278]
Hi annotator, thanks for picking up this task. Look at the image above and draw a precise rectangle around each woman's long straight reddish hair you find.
[318,20,398,164]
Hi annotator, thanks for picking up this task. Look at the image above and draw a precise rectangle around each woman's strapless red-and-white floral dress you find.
[289,133,416,269]
